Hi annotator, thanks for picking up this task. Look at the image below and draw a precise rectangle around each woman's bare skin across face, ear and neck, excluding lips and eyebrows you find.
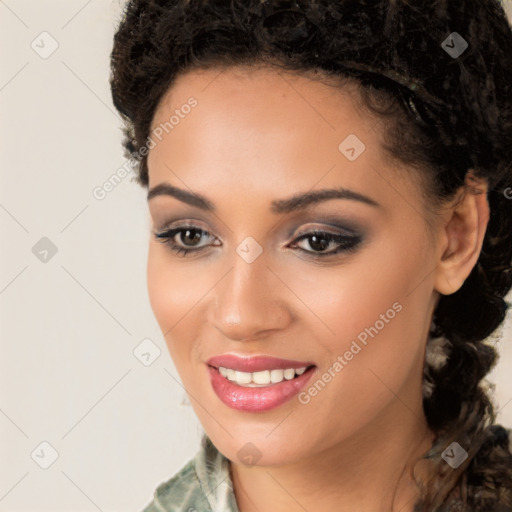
[147,68,489,512]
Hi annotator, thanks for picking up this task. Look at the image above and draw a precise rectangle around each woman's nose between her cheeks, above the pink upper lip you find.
[208,255,291,341]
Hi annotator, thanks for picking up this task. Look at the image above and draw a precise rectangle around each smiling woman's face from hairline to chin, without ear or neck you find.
[147,69,438,465]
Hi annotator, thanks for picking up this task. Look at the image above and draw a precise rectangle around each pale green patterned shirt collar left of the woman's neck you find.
[138,435,239,512]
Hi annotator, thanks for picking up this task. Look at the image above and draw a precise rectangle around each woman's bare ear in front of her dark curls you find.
[434,170,489,295]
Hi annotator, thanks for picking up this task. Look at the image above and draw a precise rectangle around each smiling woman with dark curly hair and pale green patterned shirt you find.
[111,0,512,512]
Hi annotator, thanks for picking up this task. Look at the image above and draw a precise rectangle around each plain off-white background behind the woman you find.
[0,0,512,512]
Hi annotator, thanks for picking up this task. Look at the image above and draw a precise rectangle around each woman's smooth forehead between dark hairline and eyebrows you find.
[148,67,422,216]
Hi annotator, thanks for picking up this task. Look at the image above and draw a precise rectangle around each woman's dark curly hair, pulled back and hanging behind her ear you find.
[110,0,512,512]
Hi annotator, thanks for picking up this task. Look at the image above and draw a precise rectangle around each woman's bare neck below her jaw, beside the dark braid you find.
[230,400,434,512]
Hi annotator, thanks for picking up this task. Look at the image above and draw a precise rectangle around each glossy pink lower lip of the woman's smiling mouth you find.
[208,366,315,412]
